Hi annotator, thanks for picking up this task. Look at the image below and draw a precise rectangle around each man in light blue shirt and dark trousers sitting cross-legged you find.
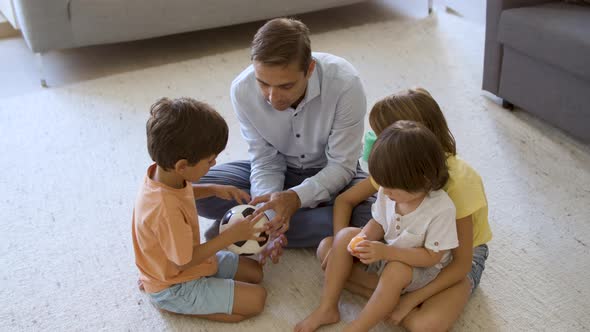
[197,18,371,260]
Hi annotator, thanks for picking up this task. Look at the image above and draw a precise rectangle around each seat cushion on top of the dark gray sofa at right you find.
[498,2,590,81]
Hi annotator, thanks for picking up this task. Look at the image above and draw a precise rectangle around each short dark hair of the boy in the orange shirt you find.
[146,98,229,170]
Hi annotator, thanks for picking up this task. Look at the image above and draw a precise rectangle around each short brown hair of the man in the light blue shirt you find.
[250,18,311,73]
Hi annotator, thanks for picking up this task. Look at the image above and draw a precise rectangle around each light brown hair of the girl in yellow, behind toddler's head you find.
[369,88,457,155]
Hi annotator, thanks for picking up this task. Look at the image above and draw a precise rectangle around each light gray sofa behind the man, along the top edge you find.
[13,0,364,53]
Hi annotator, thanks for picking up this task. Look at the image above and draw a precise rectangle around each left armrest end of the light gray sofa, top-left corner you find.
[14,0,74,52]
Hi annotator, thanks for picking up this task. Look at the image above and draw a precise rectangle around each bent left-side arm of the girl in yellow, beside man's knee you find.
[333,178,377,234]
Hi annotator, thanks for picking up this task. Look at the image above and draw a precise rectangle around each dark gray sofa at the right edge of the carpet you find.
[483,0,590,143]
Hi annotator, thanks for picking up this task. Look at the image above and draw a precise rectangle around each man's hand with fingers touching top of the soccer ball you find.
[250,190,301,237]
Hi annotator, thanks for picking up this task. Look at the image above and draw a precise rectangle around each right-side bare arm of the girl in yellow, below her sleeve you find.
[402,216,473,307]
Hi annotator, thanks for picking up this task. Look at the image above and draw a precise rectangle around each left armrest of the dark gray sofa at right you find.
[482,0,554,95]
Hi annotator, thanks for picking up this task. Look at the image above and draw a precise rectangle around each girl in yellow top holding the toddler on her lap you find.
[317,88,492,331]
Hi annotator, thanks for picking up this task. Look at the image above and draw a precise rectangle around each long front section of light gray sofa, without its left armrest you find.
[70,0,363,50]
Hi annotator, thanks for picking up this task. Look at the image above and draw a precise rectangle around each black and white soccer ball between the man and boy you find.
[219,204,269,256]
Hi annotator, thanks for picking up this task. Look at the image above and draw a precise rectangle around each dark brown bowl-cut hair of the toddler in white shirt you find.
[369,120,449,192]
